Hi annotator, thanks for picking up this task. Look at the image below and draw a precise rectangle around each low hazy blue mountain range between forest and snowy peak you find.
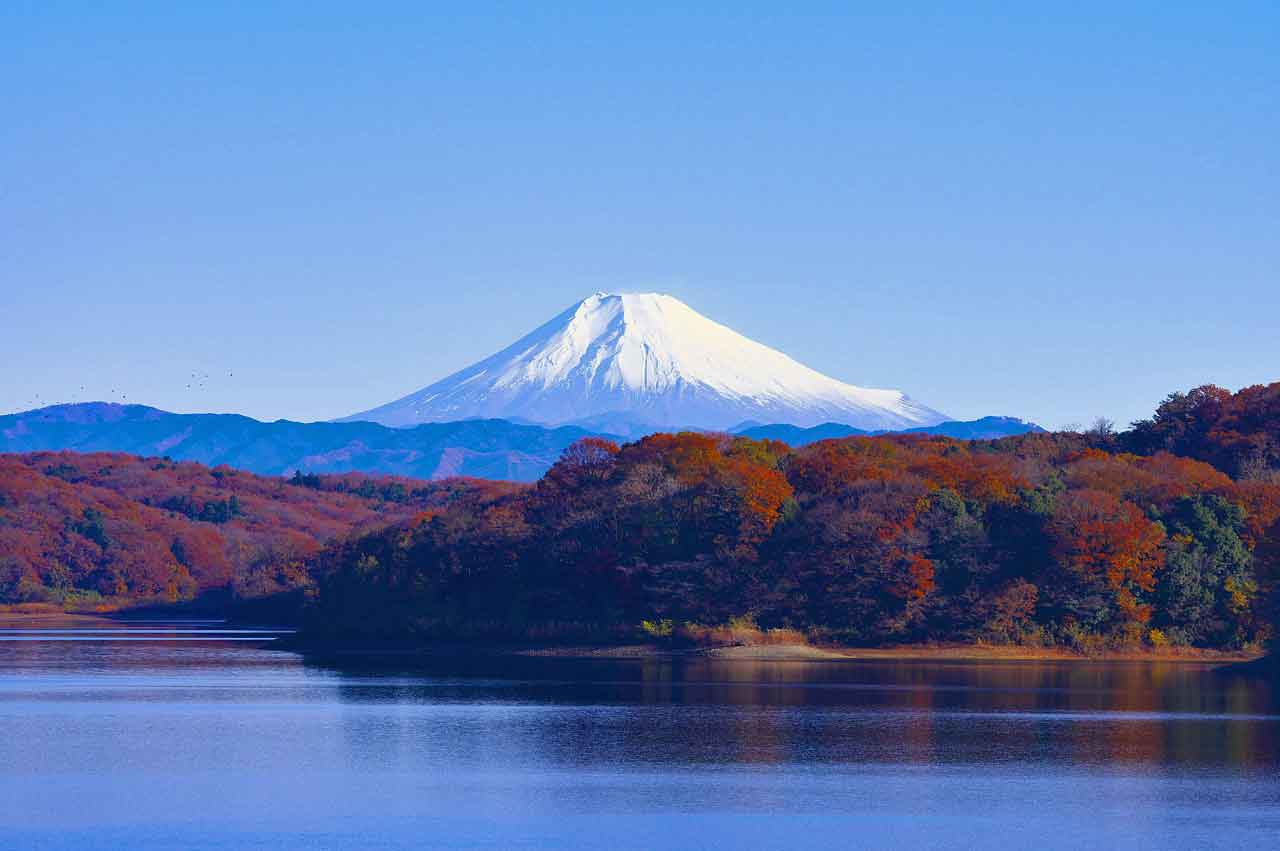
[0,402,1042,481]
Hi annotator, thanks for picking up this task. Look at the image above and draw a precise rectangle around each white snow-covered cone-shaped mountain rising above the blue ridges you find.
[347,293,947,429]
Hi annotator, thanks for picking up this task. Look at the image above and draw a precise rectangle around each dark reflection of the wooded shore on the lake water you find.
[306,656,1280,770]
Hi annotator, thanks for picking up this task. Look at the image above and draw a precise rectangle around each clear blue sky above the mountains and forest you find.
[0,1,1280,426]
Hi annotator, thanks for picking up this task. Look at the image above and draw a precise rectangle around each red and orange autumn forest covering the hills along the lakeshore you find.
[0,383,1280,651]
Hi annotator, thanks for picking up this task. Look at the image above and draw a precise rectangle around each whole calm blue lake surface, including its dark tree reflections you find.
[0,623,1280,850]
